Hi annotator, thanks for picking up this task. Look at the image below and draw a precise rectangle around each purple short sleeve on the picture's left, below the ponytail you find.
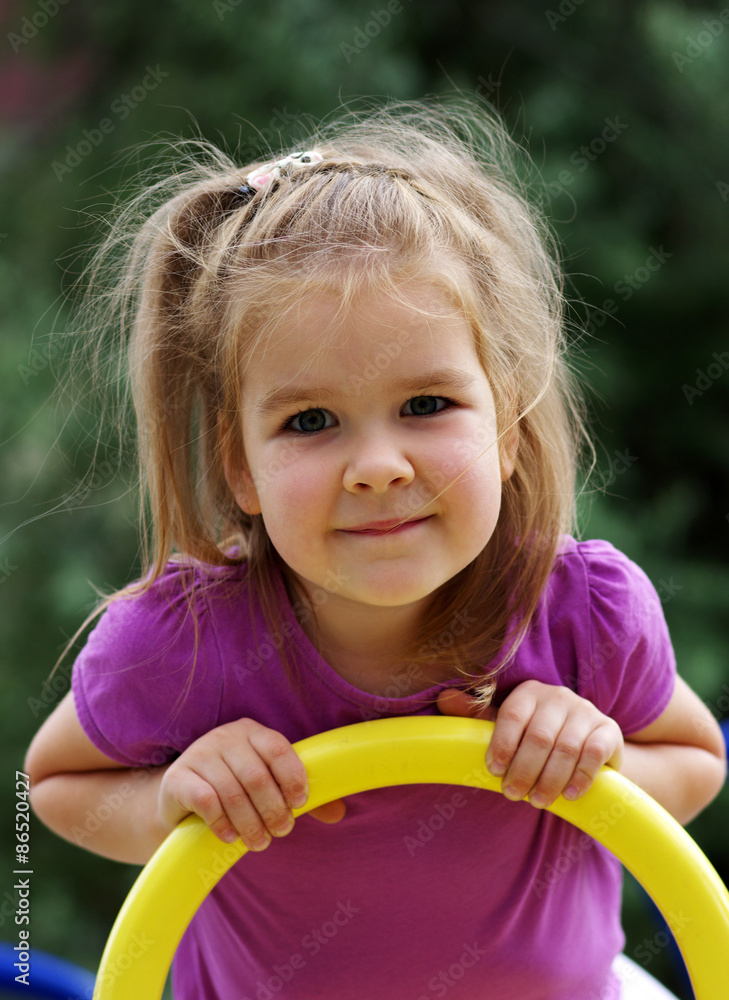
[72,571,221,767]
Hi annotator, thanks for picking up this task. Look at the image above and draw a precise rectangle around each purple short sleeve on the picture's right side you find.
[568,541,676,735]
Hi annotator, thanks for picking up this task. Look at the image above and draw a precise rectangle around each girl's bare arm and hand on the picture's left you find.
[25,693,345,864]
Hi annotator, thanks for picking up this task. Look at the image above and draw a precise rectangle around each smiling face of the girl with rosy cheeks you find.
[227,286,513,609]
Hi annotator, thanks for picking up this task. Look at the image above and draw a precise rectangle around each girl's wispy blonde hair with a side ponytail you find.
[59,100,584,700]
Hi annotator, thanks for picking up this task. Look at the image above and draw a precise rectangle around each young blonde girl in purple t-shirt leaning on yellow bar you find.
[27,105,724,1000]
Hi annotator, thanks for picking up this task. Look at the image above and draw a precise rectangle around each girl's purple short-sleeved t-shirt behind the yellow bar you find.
[73,539,675,1000]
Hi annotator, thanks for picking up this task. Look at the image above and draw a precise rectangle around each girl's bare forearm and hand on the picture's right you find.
[438,678,726,823]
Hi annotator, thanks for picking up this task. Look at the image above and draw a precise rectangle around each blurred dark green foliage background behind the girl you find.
[0,0,729,995]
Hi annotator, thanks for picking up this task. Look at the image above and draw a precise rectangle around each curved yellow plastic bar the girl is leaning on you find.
[94,716,729,1000]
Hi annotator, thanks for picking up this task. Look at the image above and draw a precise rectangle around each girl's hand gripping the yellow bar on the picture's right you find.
[438,680,623,808]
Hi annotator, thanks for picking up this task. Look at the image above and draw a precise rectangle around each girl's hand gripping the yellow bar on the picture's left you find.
[158,719,346,851]
